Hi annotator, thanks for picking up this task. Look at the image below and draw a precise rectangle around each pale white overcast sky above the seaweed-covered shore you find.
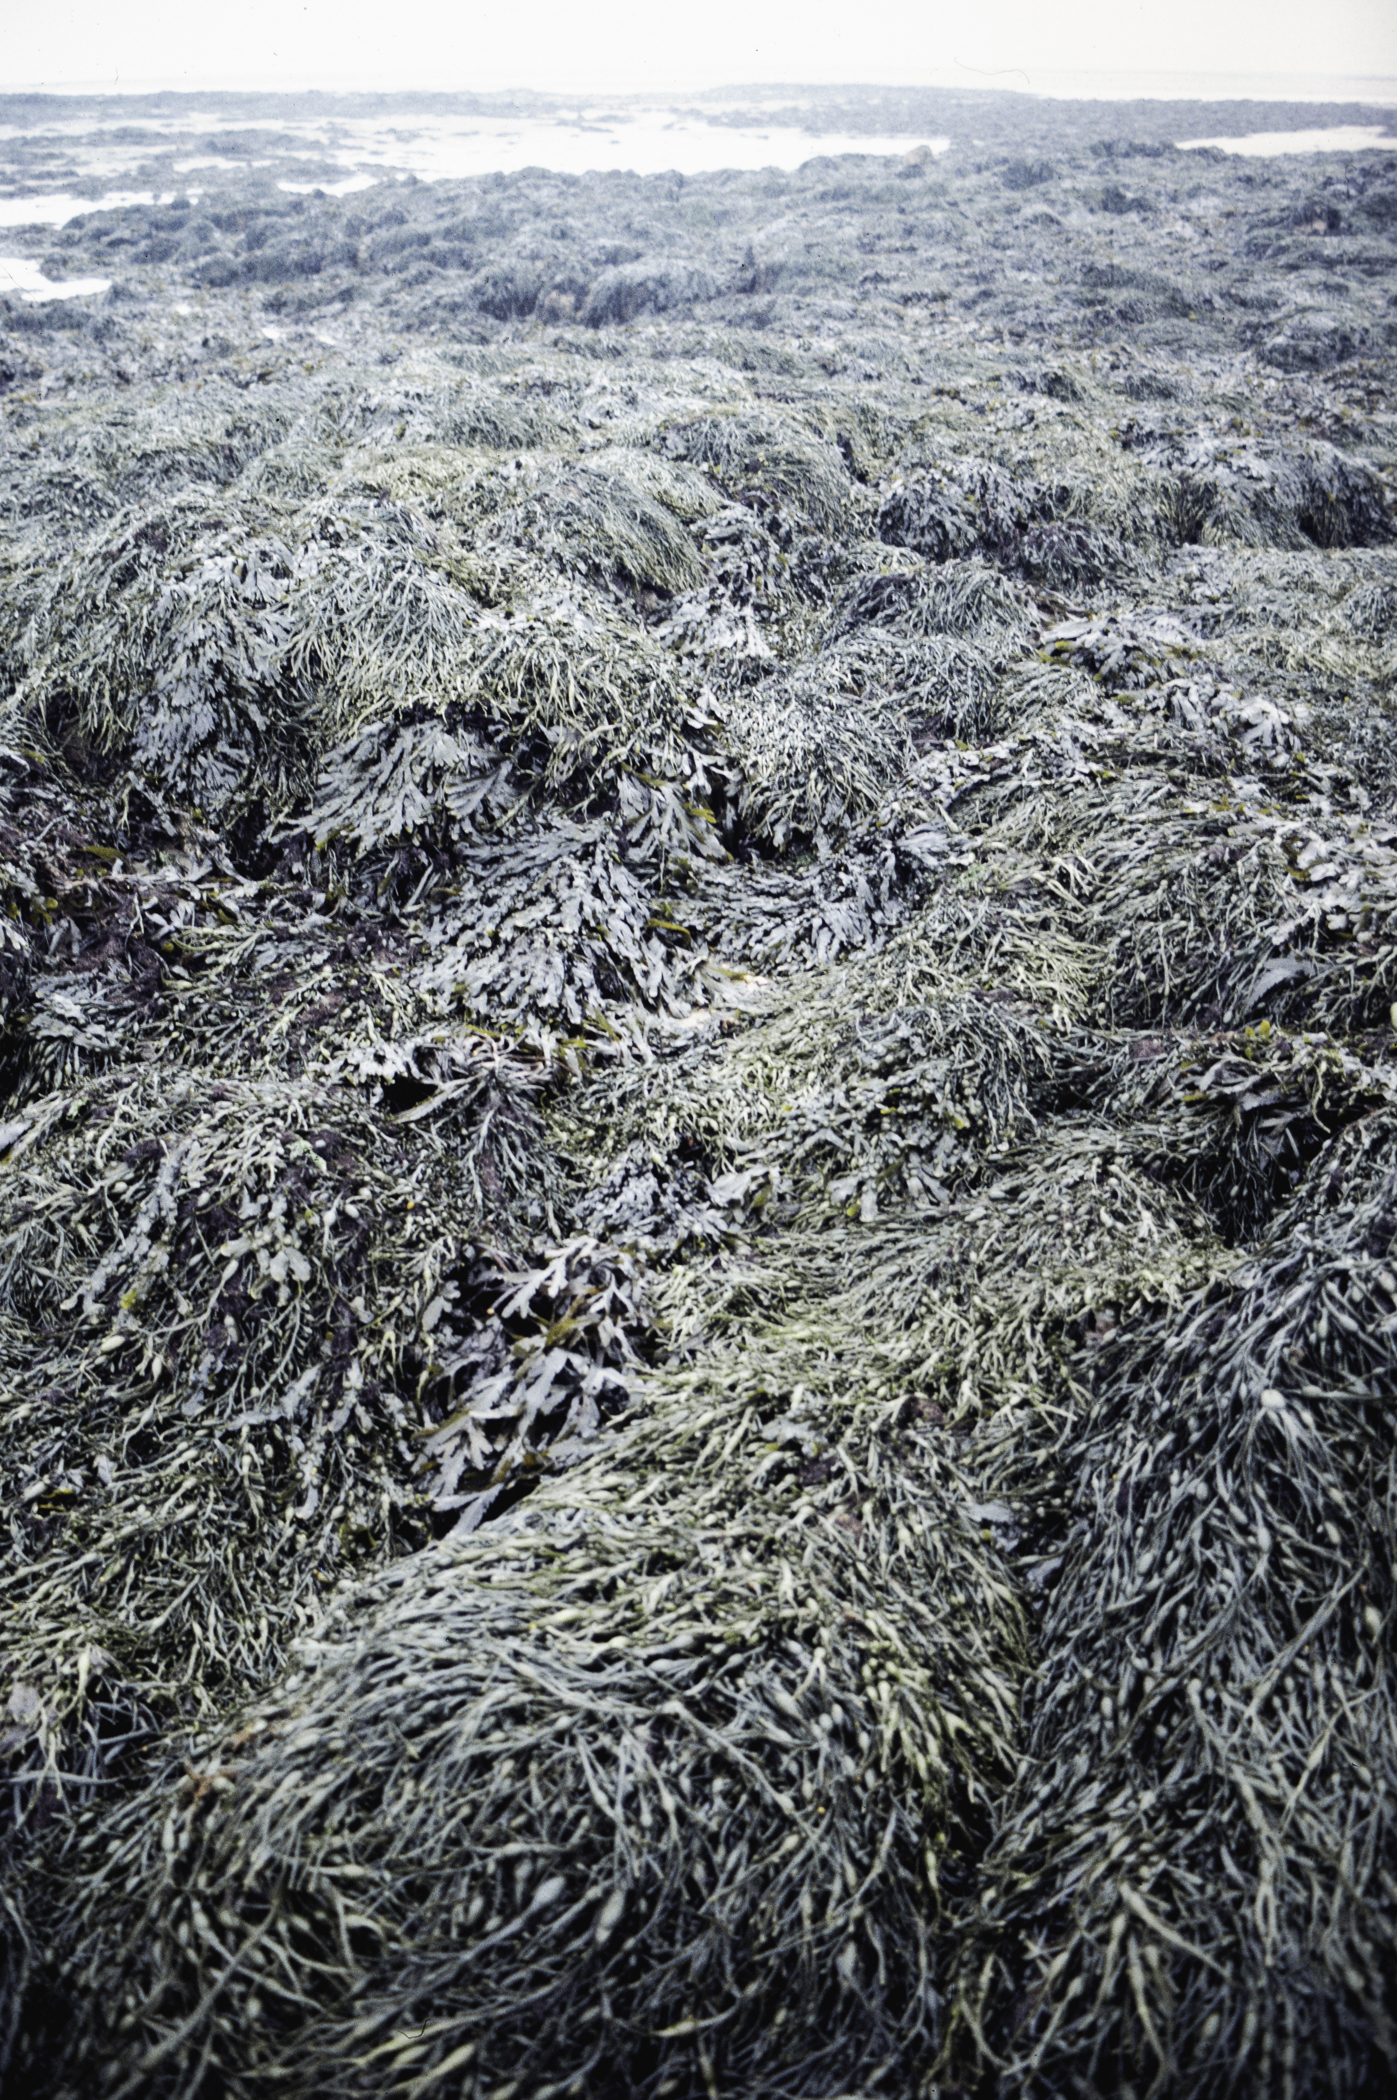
[0,0,1397,92]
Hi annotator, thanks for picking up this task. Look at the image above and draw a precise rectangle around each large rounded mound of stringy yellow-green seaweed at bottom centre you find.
[19,1382,1023,2096]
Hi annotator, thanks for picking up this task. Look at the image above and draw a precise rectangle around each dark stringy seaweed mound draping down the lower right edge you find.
[941,1109,1397,2094]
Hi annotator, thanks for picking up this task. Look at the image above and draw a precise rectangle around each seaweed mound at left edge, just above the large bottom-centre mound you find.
[0,1040,643,1825]
